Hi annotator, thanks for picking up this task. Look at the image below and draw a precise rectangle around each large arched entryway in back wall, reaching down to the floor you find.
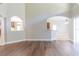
[47,16,69,40]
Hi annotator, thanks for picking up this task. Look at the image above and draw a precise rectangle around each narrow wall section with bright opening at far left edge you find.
[0,4,7,45]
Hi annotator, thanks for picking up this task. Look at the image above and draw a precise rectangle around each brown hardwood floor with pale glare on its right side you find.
[0,40,79,56]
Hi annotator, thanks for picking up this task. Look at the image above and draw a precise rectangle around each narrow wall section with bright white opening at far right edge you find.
[72,4,79,43]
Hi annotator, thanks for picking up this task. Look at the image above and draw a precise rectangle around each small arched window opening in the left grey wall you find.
[11,16,23,31]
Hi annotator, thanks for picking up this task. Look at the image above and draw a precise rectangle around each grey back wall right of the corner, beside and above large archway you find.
[26,3,69,40]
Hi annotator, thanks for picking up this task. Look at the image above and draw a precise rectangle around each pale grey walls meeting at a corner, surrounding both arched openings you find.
[0,3,72,42]
